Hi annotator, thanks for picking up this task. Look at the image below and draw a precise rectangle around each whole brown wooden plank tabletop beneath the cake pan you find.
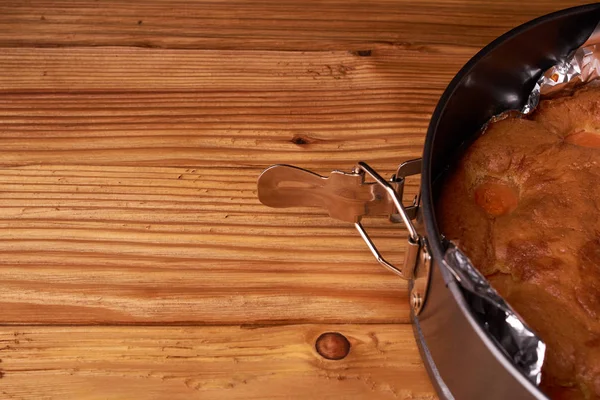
[0,0,583,400]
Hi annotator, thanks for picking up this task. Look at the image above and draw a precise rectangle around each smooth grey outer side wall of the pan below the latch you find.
[413,259,547,400]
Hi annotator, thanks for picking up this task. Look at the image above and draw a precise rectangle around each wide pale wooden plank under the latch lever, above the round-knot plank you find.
[0,164,417,324]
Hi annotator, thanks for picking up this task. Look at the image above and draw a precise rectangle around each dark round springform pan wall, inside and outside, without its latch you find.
[413,4,600,400]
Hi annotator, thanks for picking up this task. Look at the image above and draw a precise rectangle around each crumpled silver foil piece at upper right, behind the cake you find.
[521,20,600,114]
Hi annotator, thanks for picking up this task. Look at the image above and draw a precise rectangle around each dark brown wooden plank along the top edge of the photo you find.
[0,0,586,51]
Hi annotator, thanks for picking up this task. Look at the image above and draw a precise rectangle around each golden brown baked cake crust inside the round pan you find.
[437,87,600,399]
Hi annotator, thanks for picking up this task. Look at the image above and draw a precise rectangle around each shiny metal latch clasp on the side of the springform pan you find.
[258,159,431,315]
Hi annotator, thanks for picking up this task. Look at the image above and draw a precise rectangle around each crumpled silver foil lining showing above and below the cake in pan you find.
[444,24,600,385]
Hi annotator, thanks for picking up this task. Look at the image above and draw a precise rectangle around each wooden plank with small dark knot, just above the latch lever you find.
[0,47,450,170]
